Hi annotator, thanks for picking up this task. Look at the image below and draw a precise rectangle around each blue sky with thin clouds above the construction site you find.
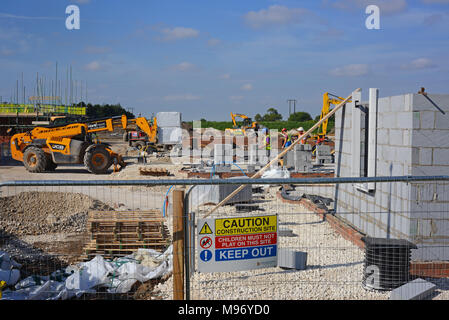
[0,0,449,121]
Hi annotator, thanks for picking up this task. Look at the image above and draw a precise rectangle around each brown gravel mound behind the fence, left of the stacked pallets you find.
[0,192,113,236]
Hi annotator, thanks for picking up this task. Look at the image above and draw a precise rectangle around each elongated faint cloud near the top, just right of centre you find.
[244,5,307,29]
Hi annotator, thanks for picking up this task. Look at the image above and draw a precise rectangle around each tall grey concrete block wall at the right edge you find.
[335,89,449,260]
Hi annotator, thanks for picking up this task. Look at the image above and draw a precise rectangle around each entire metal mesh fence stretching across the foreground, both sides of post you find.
[0,177,449,300]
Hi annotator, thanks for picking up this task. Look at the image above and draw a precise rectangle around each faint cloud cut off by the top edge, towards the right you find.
[325,0,407,14]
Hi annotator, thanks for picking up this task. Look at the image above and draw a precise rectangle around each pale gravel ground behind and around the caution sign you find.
[156,188,389,300]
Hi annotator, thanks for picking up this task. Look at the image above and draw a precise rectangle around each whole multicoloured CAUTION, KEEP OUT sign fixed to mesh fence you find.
[197,215,278,272]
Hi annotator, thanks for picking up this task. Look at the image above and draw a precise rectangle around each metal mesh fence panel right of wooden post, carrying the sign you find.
[184,179,449,300]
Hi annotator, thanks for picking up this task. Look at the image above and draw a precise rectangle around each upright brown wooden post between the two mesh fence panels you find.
[173,189,184,300]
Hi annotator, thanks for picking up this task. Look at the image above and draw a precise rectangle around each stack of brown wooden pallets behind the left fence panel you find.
[83,210,170,260]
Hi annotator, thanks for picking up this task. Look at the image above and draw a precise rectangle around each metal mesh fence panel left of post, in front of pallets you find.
[0,181,171,300]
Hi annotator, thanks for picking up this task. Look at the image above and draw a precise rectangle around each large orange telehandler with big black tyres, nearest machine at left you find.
[10,115,156,174]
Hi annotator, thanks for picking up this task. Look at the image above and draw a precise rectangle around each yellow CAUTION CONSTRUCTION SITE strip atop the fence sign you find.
[215,216,277,236]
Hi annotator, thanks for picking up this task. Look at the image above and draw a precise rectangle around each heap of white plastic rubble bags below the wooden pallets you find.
[2,246,173,300]
